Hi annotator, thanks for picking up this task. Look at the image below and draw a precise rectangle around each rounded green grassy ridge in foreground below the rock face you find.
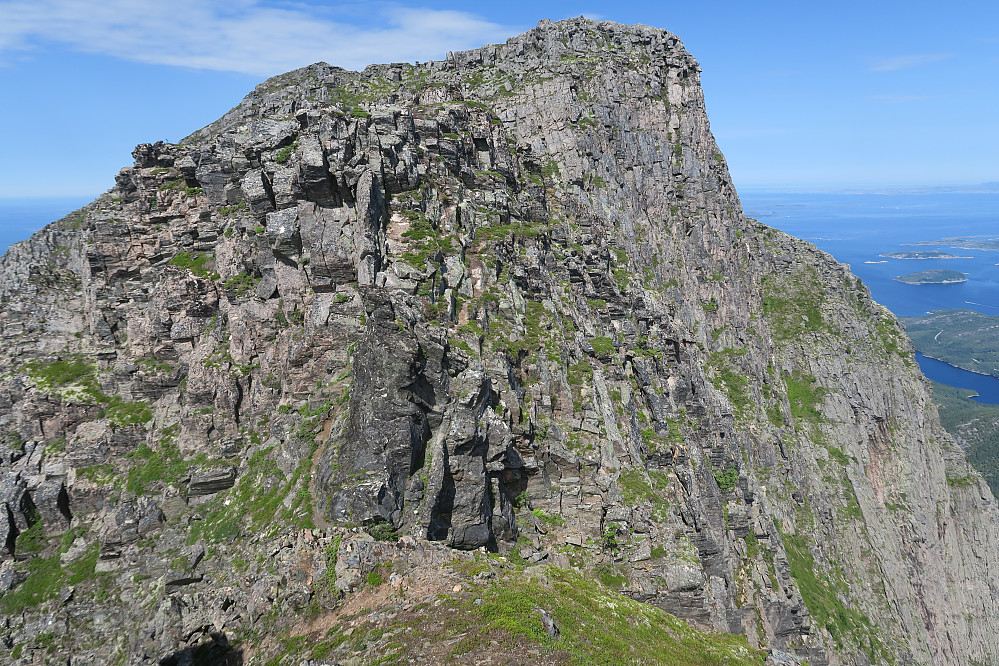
[266,557,766,666]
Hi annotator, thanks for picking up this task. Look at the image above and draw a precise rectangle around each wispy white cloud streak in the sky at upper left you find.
[0,0,523,76]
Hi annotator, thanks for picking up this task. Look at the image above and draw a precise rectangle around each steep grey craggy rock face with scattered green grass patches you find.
[0,19,999,666]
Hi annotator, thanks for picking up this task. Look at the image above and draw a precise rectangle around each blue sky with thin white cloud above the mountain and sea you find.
[0,0,999,197]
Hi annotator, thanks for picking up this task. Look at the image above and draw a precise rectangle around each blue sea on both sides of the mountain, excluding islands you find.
[0,190,999,404]
